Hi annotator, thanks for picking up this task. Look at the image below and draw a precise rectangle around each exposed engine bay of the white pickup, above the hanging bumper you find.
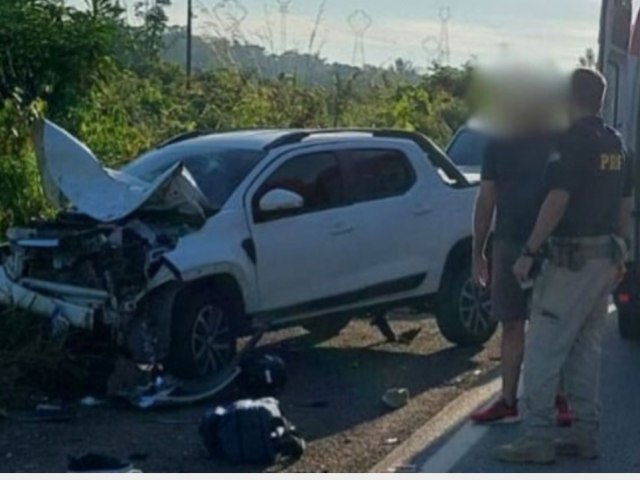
[4,212,189,305]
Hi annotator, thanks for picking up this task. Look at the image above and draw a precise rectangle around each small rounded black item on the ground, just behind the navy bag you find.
[237,355,287,398]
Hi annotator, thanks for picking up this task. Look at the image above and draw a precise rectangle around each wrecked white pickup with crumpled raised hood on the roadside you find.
[0,122,496,377]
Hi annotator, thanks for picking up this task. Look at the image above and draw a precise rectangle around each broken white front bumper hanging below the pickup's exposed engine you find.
[0,267,100,329]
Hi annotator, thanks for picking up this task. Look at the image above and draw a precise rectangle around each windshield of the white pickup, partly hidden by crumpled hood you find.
[122,142,265,210]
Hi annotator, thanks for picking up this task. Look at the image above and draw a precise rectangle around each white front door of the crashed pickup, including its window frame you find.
[243,145,358,311]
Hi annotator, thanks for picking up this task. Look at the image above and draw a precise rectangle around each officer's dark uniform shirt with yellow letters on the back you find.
[546,117,633,237]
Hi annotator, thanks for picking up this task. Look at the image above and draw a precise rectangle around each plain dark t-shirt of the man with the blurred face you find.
[481,135,557,245]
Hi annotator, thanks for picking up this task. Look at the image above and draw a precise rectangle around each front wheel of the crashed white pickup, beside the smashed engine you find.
[167,289,237,378]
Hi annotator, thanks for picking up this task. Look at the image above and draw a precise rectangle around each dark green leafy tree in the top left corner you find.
[0,0,122,116]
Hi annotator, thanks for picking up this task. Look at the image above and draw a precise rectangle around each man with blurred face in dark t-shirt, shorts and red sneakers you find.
[471,120,571,424]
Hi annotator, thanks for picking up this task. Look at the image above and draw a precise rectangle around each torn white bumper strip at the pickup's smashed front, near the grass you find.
[0,267,95,329]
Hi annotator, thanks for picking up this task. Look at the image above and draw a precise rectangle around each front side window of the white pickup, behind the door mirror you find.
[253,152,344,221]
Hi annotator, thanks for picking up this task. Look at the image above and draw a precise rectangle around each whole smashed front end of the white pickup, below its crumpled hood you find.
[0,212,200,361]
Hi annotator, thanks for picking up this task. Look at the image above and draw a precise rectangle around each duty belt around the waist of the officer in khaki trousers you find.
[547,235,627,271]
